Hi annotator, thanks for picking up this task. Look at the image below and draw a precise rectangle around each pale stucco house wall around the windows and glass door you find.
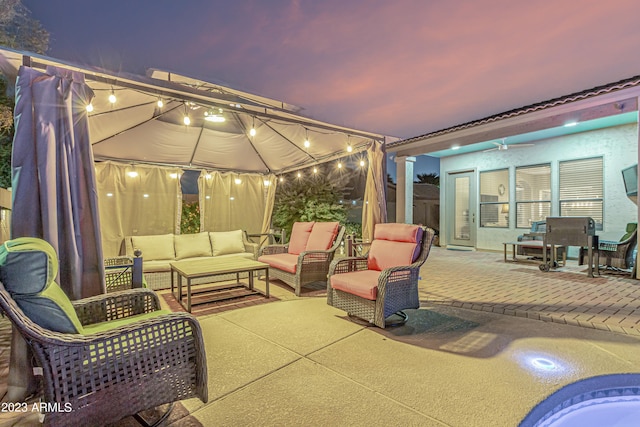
[440,124,638,255]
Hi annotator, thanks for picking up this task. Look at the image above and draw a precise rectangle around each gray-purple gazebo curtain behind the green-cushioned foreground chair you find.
[11,67,105,300]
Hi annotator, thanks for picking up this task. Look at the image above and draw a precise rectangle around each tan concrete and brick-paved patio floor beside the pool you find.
[0,247,640,427]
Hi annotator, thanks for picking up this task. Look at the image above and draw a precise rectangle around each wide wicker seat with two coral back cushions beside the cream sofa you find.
[258,222,345,296]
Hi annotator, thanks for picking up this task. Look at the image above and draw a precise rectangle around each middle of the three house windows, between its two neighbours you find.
[516,164,551,228]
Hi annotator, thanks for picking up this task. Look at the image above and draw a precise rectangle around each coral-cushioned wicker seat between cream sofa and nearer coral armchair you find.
[258,223,345,296]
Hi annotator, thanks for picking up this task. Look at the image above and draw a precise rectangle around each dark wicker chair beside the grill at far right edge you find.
[578,222,638,270]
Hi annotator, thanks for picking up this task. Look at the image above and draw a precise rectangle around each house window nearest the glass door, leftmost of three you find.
[480,169,509,227]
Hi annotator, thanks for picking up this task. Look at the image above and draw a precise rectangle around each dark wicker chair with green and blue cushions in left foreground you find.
[0,237,207,426]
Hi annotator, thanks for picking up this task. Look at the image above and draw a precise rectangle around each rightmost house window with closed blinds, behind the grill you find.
[558,157,604,230]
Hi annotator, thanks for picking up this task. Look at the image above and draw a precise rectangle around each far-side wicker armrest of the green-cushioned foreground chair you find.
[72,288,160,325]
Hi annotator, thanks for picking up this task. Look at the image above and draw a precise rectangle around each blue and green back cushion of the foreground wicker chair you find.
[0,237,83,334]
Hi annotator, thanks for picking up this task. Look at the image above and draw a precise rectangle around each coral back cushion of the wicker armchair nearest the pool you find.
[367,224,422,271]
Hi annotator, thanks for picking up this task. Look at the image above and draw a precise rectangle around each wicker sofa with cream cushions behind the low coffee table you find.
[121,230,259,289]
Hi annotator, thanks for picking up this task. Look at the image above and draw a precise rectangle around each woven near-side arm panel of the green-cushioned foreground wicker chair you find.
[33,313,208,405]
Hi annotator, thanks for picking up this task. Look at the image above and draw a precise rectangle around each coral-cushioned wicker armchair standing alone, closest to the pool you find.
[327,224,435,328]
